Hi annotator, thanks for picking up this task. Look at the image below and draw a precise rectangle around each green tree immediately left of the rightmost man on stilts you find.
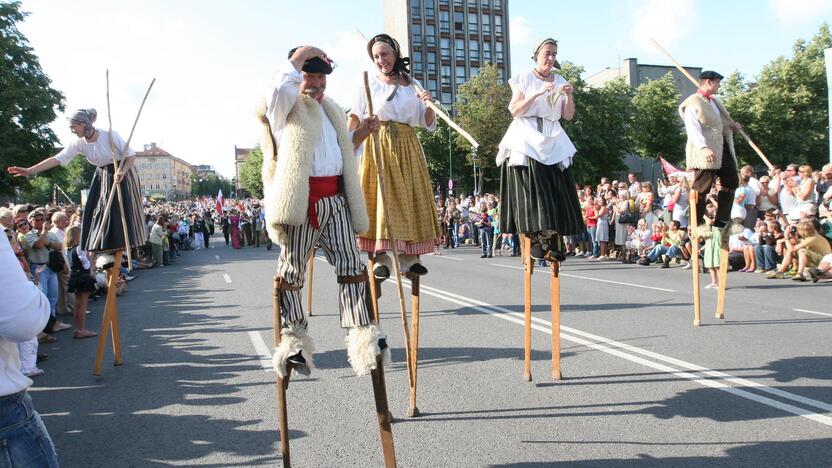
[631,72,686,163]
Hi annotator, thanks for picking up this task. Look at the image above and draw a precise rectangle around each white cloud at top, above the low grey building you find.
[630,0,698,50]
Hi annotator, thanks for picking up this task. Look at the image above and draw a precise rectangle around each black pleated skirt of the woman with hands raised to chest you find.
[500,158,586,236]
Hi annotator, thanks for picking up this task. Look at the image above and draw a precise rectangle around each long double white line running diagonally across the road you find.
[394,282,832,427]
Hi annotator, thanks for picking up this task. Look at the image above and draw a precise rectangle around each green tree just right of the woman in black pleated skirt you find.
[561,62,633,182]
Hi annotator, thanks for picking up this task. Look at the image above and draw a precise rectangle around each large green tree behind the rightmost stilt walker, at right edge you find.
[722,23,832,168]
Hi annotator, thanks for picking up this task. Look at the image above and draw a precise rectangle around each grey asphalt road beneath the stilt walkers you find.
[31,236,832,467]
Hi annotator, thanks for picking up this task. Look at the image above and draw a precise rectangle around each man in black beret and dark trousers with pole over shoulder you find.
[679,70,742,241]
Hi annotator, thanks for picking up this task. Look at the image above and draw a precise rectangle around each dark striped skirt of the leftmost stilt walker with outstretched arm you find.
[81,164,147,252]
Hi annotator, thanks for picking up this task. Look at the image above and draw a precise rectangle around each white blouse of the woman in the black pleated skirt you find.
[497,71,577,168]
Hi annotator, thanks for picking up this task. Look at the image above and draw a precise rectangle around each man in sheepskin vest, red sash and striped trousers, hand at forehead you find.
[262,46,389,377]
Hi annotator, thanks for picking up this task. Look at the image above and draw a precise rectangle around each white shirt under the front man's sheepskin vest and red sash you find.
[266,60,352,177]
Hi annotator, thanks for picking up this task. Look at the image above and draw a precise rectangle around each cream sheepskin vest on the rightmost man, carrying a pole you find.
[679,93,736,169]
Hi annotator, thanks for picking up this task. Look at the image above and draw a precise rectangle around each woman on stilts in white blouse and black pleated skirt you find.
[497,38,585,258]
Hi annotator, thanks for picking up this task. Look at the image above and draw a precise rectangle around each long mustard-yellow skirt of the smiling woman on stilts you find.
[358,122,442,255]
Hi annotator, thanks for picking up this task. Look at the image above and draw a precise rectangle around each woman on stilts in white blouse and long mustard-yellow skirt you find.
[348,34,442,278]
